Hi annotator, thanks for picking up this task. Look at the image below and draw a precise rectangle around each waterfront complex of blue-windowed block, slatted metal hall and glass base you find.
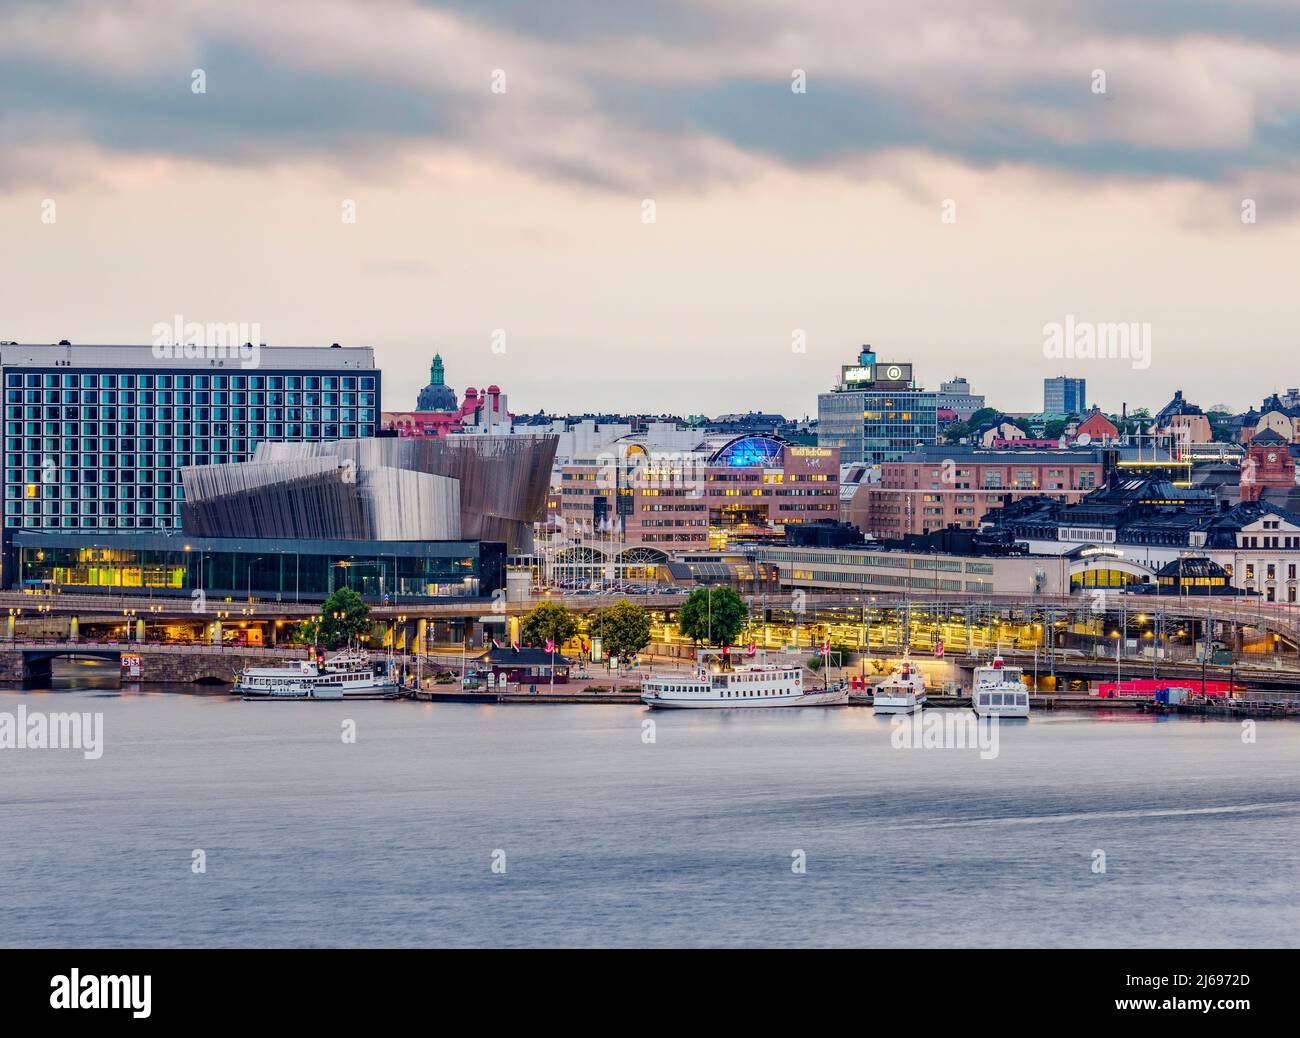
[0,343,555,642]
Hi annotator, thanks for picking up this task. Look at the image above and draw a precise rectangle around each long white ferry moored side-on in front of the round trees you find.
[641,661,849,710]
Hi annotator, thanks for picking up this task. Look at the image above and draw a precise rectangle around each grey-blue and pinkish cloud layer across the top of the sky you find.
[0,0,1300,194]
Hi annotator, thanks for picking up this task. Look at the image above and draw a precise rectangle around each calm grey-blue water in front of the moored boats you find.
[0,689,1300,946]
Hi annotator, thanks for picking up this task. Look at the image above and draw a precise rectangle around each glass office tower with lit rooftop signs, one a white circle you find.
[818,346,939,466]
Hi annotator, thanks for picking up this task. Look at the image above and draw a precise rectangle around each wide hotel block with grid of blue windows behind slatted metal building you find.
[0,342,381,533]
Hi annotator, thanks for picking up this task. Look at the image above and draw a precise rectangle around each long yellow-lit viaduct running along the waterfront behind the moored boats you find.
[0,589,1300,688]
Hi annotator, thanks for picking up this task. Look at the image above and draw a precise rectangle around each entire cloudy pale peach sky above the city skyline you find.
[0,0,1300,416]
